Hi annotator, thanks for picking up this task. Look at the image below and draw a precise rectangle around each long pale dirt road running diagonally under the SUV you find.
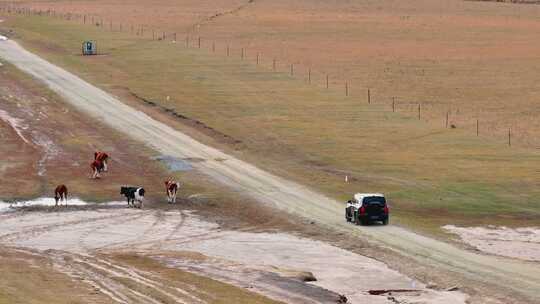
[0,40,540,301]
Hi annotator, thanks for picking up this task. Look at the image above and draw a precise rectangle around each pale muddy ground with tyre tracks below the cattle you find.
[0,203,467,303]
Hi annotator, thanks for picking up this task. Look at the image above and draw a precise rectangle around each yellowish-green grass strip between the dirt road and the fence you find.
[3,17,540,232]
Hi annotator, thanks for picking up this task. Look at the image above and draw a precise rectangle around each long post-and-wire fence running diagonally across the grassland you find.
[0,3,524,147]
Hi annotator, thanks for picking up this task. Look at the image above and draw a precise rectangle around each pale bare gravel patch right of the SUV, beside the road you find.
[442,225,540,261]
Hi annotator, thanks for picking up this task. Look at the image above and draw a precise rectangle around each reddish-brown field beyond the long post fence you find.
[6,0,540,147]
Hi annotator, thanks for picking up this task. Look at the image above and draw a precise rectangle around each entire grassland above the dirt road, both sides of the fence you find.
[2,1,540,235]
